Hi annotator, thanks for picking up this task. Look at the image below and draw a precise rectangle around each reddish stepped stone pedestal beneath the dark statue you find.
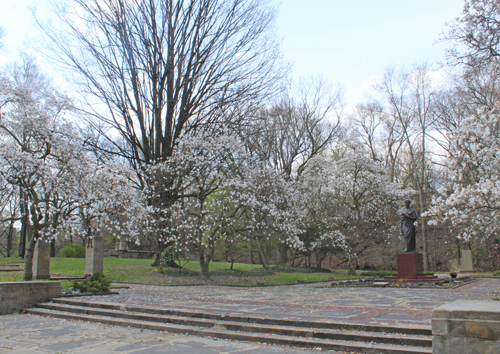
[384,252,438,282]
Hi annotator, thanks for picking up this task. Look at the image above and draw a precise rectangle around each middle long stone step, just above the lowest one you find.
[33,303,432,347]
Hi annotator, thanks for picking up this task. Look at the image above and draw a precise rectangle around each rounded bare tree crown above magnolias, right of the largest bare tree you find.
[243,77,343,178]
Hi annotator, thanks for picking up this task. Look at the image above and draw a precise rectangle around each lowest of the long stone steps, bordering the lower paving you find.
[26,308,432,354]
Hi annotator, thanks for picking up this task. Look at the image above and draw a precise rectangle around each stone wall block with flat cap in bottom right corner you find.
[432,300,500,354]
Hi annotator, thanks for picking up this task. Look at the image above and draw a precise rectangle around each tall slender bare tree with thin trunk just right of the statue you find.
[355,64,446,270]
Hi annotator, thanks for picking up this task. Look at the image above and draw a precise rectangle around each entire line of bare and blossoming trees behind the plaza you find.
[0,0,500,280]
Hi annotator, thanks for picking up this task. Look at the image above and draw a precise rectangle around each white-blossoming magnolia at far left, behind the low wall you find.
[0,58,146,280]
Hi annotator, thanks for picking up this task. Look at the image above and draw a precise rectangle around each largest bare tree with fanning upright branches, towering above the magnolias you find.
[40,0,283,261]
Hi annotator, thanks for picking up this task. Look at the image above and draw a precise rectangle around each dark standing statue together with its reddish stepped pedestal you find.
[384,199,438,282]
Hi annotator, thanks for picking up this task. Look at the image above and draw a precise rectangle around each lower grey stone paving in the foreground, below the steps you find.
[0,314,350,354]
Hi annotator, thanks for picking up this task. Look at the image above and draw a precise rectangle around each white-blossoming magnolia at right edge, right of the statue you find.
[428,109,500,242]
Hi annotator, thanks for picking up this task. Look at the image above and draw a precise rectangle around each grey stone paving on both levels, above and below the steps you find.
[0,279,500,354]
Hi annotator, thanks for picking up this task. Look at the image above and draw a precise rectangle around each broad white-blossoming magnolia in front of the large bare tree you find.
[148,134,304,278]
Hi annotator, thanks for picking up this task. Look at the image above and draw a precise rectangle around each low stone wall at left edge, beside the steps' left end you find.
[0,281,61,315]
